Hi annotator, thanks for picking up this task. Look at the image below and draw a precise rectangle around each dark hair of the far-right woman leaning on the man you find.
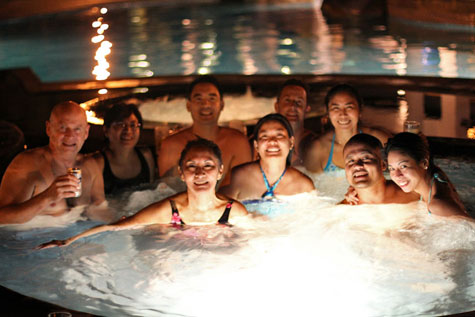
[384,132,441,175]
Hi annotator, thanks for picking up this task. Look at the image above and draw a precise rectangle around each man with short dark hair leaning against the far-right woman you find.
[342,133,418,204]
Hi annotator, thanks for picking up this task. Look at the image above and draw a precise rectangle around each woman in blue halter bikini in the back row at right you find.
[304,84,389,173]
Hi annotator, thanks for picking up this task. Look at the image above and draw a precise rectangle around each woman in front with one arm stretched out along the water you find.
[39,139,247,248]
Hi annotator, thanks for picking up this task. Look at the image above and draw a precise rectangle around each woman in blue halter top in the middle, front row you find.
[222,113,315,200]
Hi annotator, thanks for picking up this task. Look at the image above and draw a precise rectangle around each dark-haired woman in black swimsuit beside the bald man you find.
[94,103,155,195]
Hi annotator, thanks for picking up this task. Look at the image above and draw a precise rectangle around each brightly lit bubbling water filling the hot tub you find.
[0,172,475,316]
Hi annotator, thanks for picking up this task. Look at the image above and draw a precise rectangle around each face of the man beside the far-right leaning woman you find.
[343,143,384,188]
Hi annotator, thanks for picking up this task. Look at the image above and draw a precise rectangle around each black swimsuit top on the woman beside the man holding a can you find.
[101,148,150,194]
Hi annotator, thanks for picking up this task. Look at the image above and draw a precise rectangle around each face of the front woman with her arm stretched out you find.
[179,148,224,191]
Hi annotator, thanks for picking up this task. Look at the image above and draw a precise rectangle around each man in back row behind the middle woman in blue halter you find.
[274,79,315,165]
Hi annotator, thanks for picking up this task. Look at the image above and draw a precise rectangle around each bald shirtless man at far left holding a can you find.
[0,101,108,224]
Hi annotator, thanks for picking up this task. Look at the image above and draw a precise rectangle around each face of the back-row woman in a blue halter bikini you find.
[328,92,360,129]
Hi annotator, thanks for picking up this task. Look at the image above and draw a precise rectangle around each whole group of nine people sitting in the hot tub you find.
[0,76,468,247]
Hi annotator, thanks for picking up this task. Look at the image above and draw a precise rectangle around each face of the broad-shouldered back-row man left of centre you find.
[186,83,224,124]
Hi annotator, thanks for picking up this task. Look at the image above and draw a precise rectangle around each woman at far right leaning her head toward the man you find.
[385,132,468,216]
